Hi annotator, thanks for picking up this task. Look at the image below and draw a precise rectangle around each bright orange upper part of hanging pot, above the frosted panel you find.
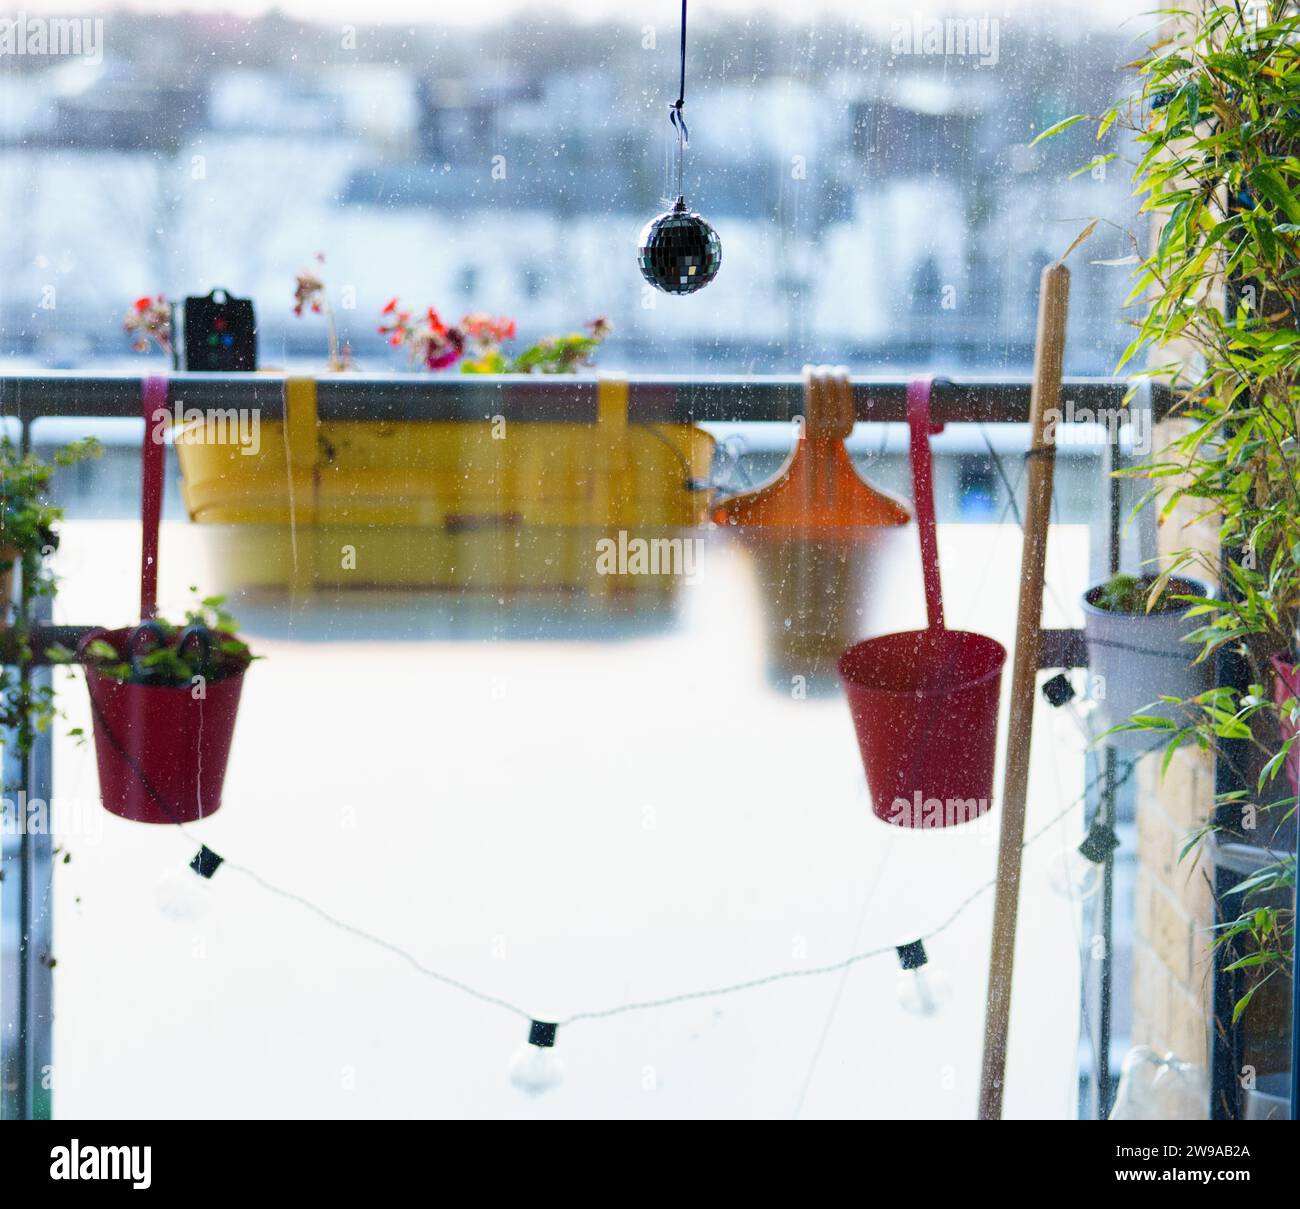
[714,365,911,530]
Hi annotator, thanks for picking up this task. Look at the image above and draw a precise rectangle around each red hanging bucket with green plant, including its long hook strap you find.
[78,377,252,823]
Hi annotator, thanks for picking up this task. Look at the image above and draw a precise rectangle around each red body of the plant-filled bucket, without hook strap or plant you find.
[82,623,248,823]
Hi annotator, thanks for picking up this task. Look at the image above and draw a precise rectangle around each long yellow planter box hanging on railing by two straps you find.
[177,378,714,590]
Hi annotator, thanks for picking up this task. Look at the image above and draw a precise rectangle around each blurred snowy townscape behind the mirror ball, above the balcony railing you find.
[0,12,1134,373]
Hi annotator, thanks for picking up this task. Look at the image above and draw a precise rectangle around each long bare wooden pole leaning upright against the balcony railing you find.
[979,261,1070,1121]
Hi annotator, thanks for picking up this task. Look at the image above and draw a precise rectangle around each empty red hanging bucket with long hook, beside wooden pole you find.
[839,378,1006,828]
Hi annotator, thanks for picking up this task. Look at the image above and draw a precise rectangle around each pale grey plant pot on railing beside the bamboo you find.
[1083,576,1214,755]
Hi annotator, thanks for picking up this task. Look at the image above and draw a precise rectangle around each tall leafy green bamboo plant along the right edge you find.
[1039,0,1300,1019]
